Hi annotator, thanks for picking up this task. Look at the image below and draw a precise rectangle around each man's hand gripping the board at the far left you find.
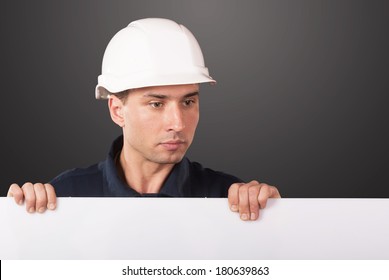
[7,183,57,213]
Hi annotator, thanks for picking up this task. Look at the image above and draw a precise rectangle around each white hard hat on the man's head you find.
[96,18,216,99]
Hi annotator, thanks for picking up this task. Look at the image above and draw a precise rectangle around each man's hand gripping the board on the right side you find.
[228,180,281,221]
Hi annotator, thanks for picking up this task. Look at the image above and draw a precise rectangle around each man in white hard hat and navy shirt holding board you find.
[8,19,280,220]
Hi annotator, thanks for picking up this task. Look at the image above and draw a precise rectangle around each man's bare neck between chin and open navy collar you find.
[117,150,174,194]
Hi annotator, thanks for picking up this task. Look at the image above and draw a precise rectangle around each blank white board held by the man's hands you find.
[0,198,389,259]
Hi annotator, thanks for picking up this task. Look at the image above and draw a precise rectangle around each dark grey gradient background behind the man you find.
[0,0,389,197]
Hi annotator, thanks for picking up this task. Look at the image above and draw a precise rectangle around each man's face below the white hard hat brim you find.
[122,84,199,164]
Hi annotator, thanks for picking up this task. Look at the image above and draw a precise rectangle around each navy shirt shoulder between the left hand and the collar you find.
[50,163,103,196]
